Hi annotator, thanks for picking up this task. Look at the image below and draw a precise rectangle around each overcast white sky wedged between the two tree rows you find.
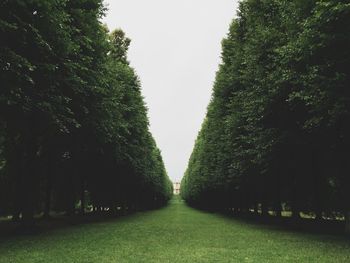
[104,0,238,181]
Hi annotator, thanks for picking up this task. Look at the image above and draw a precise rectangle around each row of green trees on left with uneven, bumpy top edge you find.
[0,0,172,225]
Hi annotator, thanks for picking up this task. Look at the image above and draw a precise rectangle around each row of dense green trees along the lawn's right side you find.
[181,0,350,231]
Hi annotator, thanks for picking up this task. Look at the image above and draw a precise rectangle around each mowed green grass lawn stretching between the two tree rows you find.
[0,198,350,263]
